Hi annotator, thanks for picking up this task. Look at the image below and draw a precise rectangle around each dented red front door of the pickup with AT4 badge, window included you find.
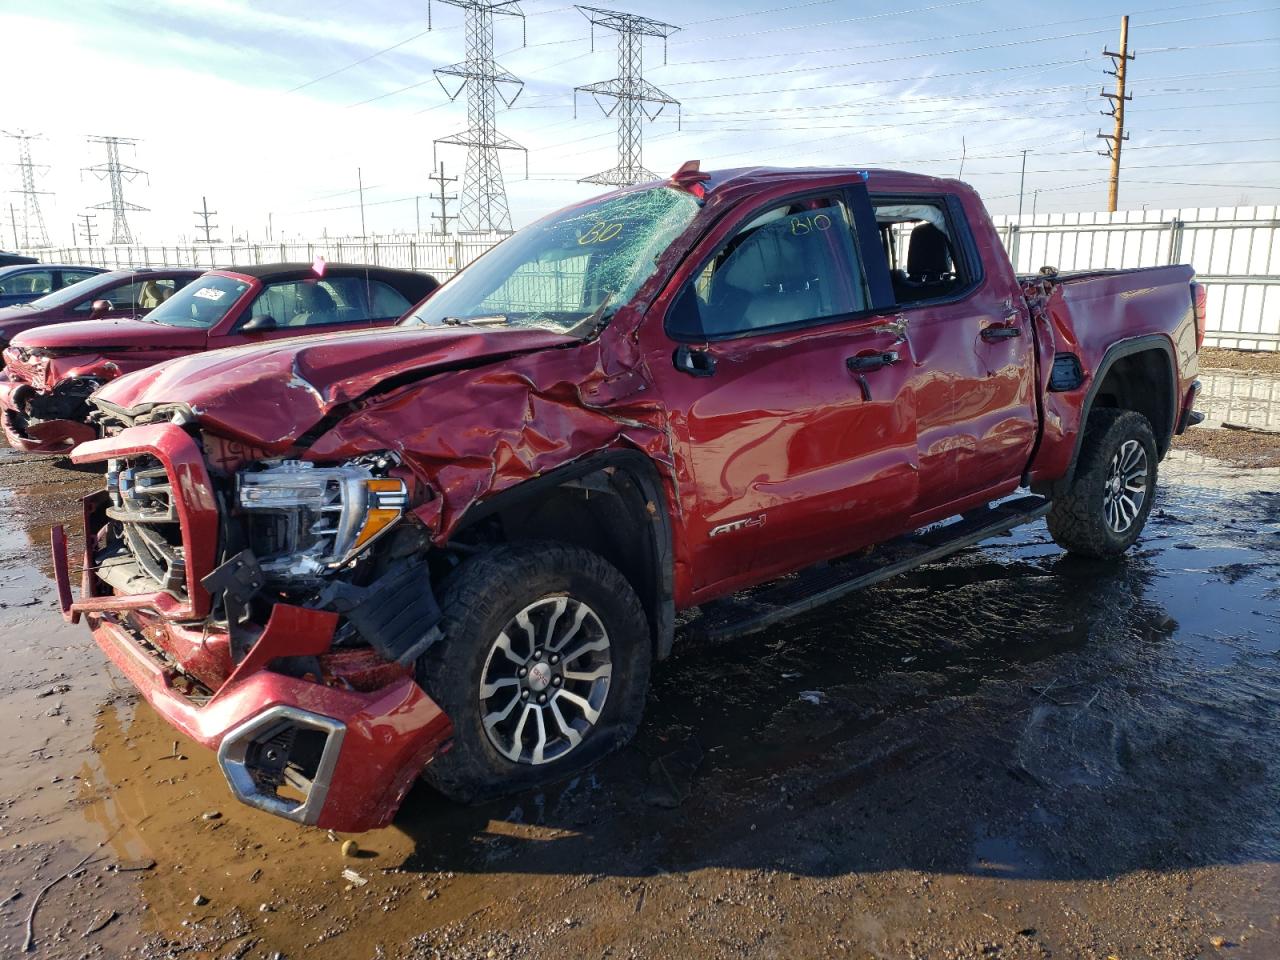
[649,183,918,602]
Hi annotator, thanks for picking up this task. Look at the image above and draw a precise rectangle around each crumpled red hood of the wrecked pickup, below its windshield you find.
[96,326,580,449]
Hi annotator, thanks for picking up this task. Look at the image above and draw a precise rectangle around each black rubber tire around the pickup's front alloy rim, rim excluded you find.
[417,541,652,803]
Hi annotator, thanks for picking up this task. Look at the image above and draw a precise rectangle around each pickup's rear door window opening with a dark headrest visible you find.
[872,197,978,303]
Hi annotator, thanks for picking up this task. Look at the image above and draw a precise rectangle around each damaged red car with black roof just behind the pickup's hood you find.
[0,264,439,454]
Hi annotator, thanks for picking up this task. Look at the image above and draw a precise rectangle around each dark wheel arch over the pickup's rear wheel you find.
[1055,334,1179,493]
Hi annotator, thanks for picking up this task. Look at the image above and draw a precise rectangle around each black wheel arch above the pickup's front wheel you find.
[451,449,676,659]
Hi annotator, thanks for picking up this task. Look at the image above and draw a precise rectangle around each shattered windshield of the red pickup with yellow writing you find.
[401,187,698,337]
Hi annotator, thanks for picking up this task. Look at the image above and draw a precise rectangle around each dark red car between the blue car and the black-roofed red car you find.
[0,266,204,349]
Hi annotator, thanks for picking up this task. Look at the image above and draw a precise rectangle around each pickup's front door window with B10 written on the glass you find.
[668,196,870,339]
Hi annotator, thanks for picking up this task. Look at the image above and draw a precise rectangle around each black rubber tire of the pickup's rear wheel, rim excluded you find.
[1048,408,1157,559]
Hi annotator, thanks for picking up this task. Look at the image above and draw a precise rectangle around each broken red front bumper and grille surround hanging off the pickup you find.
[52,424,452,832]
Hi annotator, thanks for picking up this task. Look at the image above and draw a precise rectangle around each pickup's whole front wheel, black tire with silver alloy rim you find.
[419,541,650,801]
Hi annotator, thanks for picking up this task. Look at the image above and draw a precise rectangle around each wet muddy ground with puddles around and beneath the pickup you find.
[0,363,1280,960]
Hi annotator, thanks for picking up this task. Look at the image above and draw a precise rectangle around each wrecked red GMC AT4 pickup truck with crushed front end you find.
[54,163,1204,831]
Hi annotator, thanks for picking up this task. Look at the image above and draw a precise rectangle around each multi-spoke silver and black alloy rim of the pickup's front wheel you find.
[480,596,613,764]
